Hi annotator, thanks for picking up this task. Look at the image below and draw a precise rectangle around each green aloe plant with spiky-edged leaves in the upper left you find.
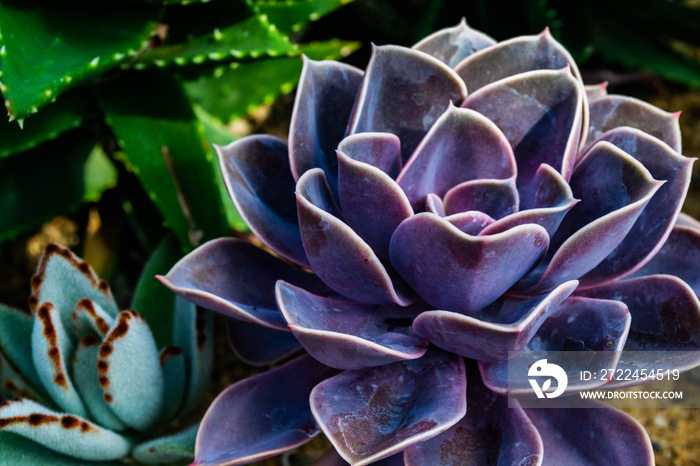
[0,0,357,249]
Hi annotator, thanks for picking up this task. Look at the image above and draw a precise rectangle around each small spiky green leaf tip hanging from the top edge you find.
[252,0,353,34]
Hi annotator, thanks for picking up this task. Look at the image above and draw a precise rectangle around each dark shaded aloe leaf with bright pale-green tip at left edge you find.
[0,131,117,241]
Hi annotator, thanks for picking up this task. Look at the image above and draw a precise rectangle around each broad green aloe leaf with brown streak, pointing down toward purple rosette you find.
[97,72,228,249]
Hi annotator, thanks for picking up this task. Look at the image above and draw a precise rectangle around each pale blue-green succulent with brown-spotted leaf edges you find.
[0,244,213,466]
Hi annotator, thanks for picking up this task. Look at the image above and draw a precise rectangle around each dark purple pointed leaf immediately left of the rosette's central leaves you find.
[338,150,413,257]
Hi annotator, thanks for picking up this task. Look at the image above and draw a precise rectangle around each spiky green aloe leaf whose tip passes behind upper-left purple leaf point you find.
[185,40,359,122]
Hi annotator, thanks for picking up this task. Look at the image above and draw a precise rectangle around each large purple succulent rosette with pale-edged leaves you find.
[161,22,700,465]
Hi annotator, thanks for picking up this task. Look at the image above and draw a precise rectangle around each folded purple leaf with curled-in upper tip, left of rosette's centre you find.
[296,169,411,305]
